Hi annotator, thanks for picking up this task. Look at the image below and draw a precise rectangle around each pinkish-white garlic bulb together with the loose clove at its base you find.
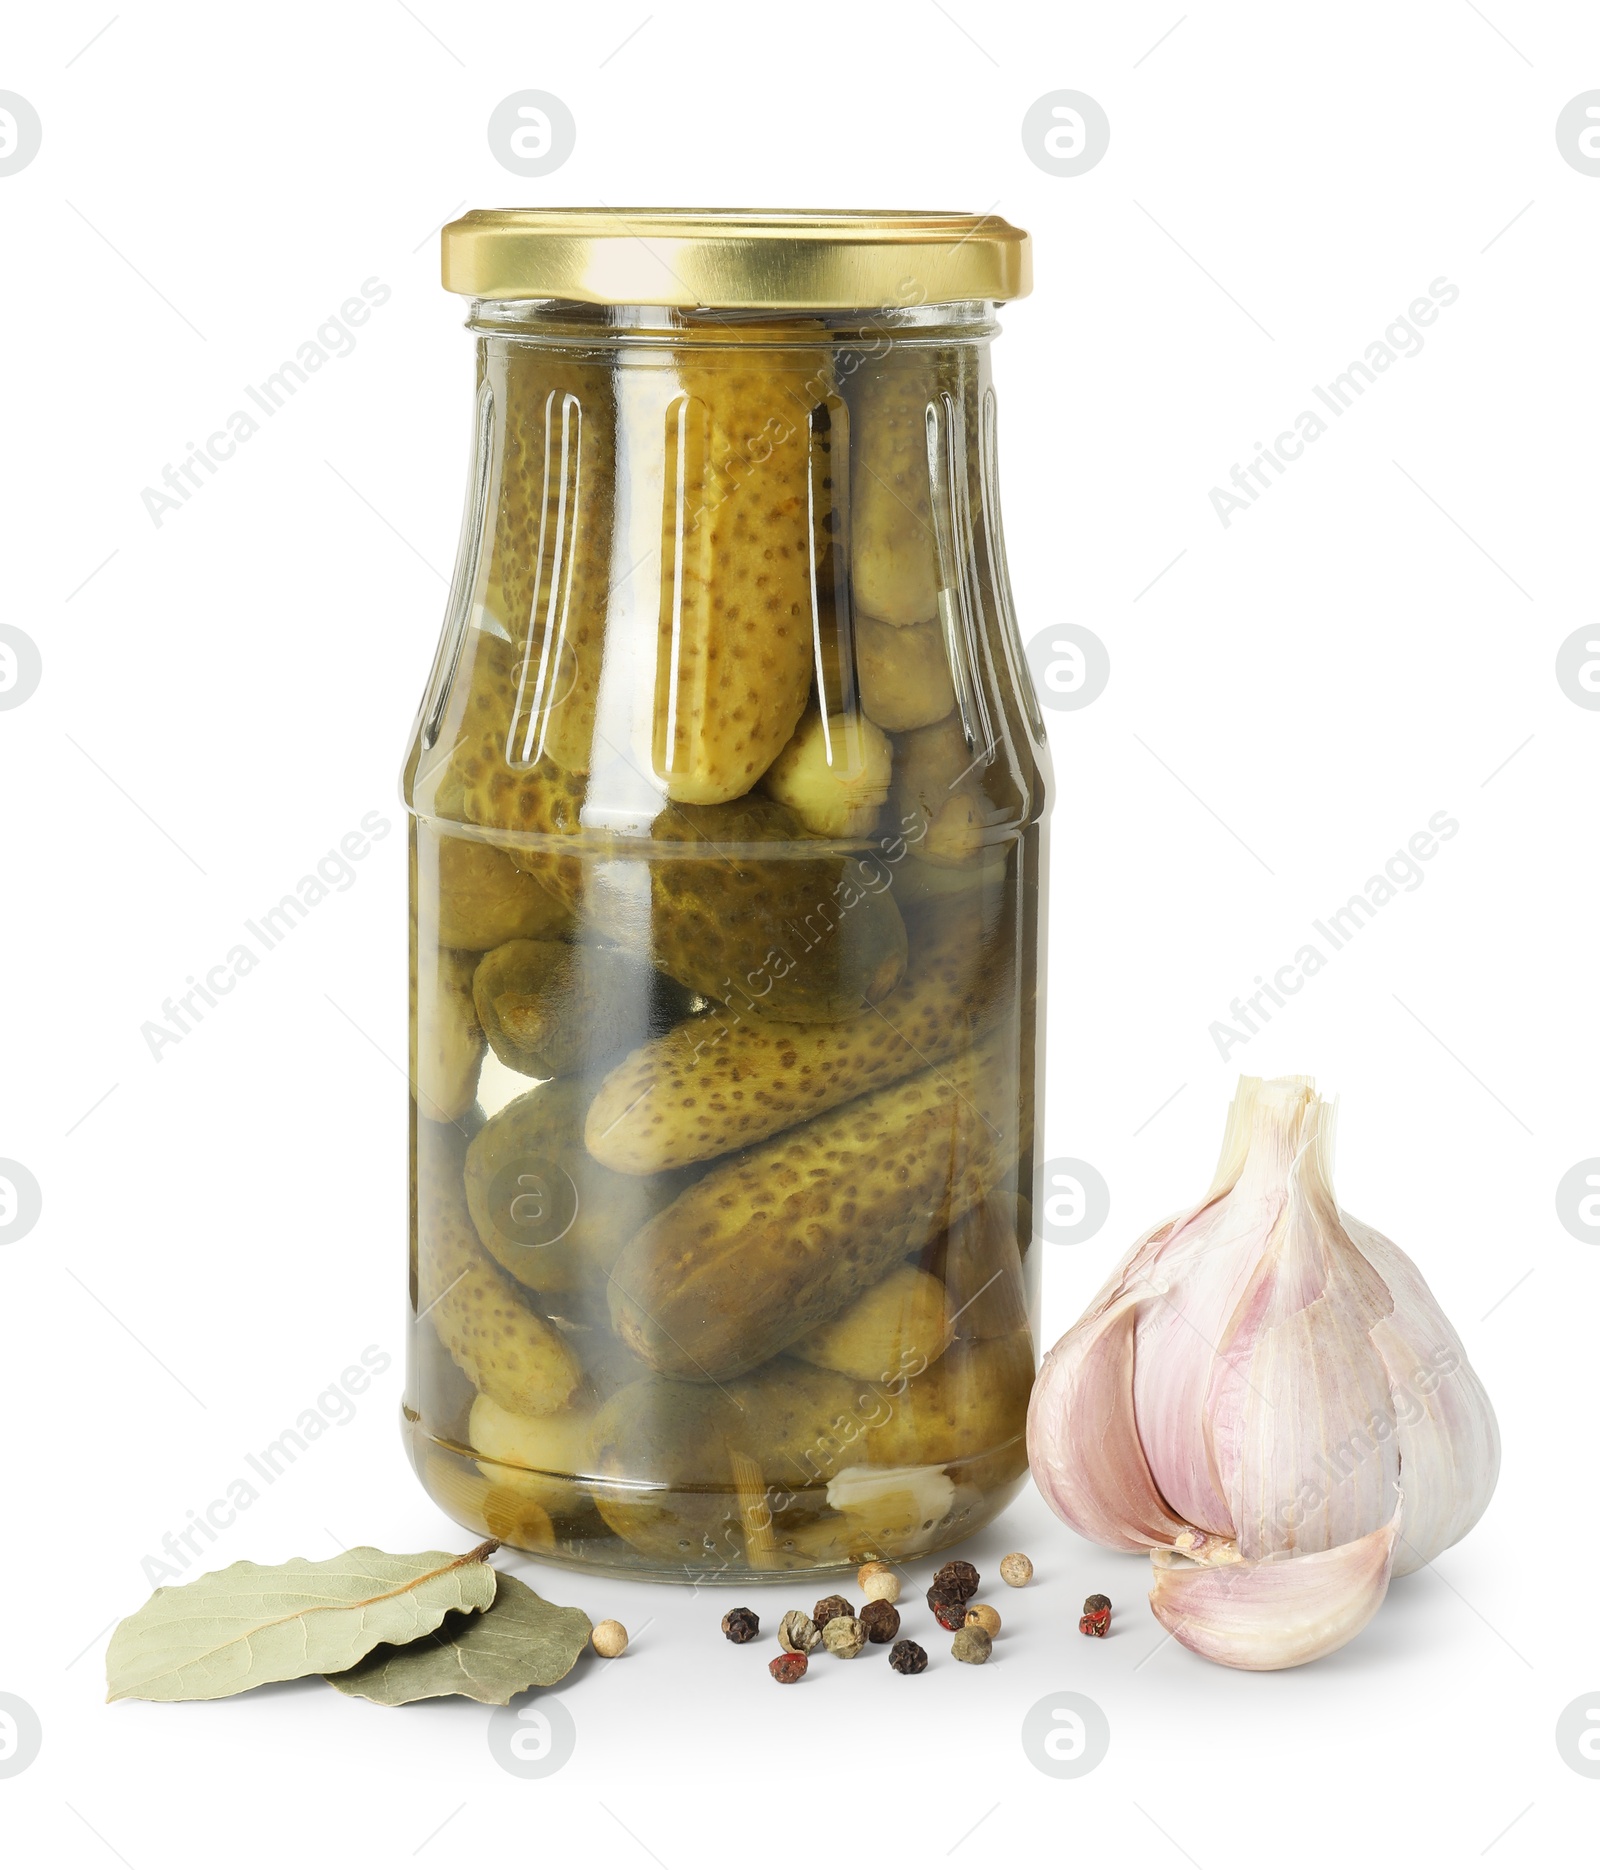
[1028,1077,1499,1668]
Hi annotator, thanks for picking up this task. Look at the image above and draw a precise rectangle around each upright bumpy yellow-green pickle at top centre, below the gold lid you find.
[652,348,832,804]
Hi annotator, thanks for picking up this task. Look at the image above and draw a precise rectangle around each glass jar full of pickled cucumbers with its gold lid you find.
[404,211,1049,1580]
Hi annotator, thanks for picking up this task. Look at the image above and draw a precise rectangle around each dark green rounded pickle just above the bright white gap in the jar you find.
[473,941,688,1077]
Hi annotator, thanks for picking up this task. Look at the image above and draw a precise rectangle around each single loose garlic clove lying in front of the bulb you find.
[1150,1502,1402,1670]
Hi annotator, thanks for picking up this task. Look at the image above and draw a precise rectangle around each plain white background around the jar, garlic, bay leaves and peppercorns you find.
[0,0,1600,1870]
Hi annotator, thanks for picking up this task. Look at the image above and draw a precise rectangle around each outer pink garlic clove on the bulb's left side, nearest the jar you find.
[1028,1298,1187,1552]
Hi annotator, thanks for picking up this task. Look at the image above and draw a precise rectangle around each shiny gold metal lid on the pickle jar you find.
[441,208,1034,310]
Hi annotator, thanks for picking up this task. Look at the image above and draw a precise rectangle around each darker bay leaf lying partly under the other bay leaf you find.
[327,1573,591,1707]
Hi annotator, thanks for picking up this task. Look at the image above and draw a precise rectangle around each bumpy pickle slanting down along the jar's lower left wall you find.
[417,1151,581,1416]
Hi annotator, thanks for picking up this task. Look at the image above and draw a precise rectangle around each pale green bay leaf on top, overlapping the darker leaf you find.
[107,1539,499,1702]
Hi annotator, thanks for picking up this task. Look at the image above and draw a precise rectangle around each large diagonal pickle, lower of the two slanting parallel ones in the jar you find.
[611,1036,1021,1380]
